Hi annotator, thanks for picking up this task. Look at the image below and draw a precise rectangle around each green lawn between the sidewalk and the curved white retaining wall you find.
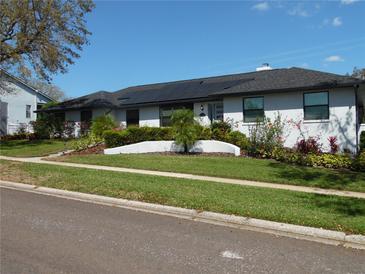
[52,154,365,192]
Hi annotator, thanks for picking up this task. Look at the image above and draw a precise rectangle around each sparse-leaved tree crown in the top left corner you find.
[0,0,94,86]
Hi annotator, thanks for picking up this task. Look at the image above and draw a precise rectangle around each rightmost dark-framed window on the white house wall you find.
[304,91,329,120]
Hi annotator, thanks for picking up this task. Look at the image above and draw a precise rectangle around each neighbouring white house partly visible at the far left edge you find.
[0,71,53,135]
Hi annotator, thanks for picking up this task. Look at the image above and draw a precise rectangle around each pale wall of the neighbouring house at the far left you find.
[0,77,51,134]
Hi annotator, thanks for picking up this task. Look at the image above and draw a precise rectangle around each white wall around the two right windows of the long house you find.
[223,88,356,151]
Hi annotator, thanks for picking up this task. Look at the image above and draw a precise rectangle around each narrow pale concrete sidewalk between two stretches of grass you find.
[0,156,365,199]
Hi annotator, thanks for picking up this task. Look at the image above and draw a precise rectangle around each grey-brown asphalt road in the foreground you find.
[0,188,365,274]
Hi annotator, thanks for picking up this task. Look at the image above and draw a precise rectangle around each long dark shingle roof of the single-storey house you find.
[43,67,363,109]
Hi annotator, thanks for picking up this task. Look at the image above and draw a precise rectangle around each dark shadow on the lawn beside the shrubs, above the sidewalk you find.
[269,162,365,189]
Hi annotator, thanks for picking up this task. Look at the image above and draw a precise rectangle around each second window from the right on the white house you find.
[243,97,265,123]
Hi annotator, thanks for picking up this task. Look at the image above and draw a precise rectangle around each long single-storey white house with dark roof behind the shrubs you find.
[39,67,365,152]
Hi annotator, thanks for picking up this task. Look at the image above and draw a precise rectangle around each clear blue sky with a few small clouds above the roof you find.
[53,0,365,97]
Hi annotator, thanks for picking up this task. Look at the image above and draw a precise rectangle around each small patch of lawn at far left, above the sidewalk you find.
[0,140,74,157]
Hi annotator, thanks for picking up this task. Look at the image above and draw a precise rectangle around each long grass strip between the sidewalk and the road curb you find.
[0,161,365,234]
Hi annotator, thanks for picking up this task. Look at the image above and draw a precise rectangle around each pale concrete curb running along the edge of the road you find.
[0,180,365,250]
